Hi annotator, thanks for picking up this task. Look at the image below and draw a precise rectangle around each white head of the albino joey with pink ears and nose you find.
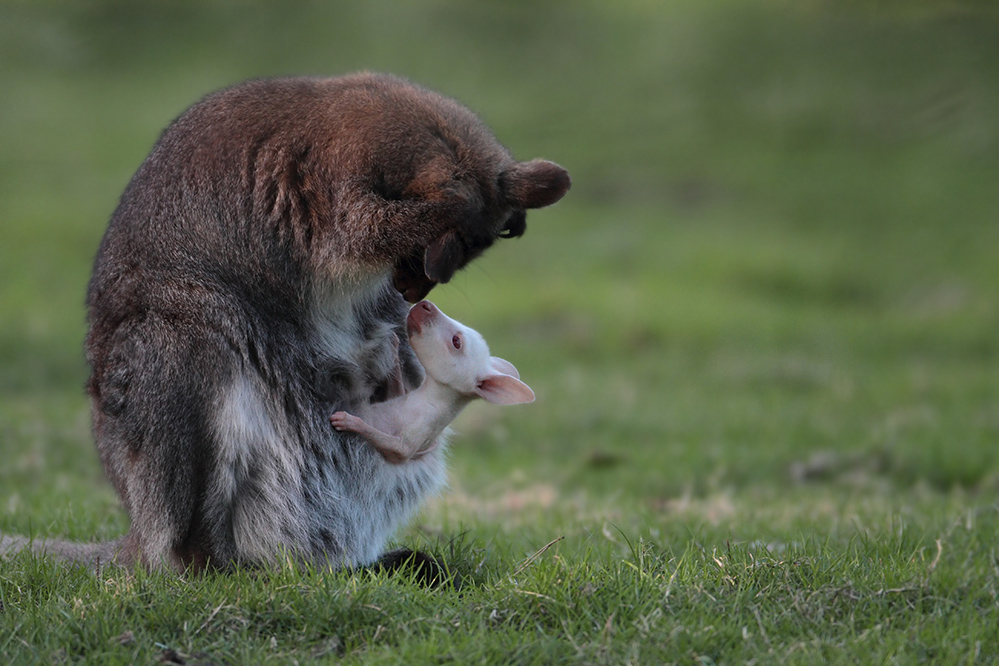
[406,301,534,405]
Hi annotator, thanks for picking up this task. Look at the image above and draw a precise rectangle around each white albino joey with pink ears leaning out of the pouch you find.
[330,301,534,464]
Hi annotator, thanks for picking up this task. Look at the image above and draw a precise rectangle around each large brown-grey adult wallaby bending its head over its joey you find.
[0,73,570,571]
